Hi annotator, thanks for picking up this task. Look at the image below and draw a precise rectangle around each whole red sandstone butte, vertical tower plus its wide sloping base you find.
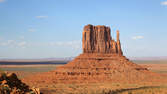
[23,24,165,84]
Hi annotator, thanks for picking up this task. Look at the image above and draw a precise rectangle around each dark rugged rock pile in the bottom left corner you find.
[0,73,40,94]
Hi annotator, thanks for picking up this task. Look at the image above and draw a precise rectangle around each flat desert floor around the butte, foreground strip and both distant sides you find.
[0,61,167,94]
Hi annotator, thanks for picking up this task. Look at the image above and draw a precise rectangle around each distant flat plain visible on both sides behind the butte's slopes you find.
[0,63,167,78]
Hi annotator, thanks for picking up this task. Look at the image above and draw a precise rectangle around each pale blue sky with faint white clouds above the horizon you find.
[0,0,167,59]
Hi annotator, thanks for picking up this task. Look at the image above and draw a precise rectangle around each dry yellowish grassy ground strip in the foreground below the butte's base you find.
[41,83,167,94]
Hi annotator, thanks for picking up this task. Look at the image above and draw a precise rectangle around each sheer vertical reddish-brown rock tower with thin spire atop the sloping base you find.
[82,25,123,55]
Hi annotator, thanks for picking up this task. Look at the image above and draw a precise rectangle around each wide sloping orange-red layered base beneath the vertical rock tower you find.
[24,53,164,84]
